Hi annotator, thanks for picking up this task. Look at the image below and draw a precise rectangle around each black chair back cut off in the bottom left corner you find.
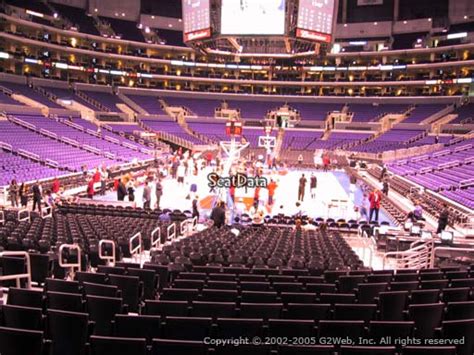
[0,327,46,355]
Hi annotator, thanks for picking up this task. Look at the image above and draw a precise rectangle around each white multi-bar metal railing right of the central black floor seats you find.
[382,240,434,270]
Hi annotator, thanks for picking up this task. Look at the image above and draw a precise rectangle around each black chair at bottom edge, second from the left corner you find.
[47,309,90,355]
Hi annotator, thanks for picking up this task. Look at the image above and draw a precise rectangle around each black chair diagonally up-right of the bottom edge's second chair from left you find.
[86,296,123,335]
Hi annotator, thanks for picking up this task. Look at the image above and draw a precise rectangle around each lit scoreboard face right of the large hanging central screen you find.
[296,0,336,43]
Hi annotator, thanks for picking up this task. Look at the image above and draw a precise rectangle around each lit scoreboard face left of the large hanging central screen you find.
[182,0,211,42]
